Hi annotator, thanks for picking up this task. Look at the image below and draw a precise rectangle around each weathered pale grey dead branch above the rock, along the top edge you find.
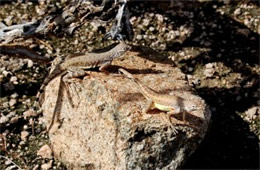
[0,0,131,44]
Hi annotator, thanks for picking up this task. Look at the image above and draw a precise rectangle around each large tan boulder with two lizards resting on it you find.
[42,46,211,169]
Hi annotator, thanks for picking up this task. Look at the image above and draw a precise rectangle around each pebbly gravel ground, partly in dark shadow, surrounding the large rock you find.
[0,0,260,169]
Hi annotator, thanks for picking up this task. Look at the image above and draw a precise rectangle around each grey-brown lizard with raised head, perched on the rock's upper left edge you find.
[34,41,131,131]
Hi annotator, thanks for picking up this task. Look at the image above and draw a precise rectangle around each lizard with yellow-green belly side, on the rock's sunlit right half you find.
[118,68,199,133]
